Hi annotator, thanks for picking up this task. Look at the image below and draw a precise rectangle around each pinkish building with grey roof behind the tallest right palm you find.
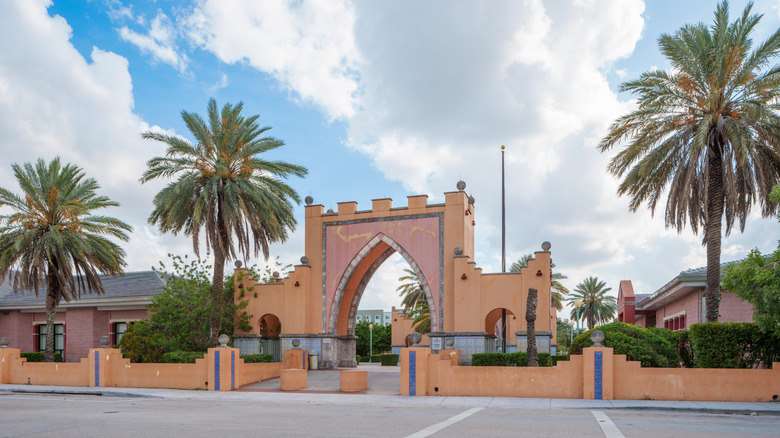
[617,264,753,330]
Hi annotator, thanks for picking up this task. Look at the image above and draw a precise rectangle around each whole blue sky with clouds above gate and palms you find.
[0,0,780,310]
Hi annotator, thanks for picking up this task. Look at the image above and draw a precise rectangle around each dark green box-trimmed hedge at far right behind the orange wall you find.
[690,322,780,368]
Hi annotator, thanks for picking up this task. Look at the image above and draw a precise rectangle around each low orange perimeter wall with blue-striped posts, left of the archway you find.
[0,348,298,391]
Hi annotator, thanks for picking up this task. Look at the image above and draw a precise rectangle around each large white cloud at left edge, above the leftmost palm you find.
[0,0,191,270]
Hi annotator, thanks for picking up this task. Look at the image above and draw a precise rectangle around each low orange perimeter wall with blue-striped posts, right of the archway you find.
[401,347,780,402]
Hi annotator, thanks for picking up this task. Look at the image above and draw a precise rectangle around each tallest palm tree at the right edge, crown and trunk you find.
[599,1,780,321]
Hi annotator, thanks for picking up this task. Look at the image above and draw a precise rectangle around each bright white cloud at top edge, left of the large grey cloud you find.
[187,0,359,119]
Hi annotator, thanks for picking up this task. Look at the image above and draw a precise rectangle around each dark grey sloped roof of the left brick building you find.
[0,271,165,307]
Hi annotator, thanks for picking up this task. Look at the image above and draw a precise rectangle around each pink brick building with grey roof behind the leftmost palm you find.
[0,271,165,362]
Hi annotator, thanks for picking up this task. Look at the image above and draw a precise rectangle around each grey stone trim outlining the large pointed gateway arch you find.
[325,233,441,334]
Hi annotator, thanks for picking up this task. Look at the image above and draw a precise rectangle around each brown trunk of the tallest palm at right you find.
[704,134,723,322]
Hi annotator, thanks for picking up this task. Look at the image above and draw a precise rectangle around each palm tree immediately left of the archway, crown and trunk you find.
[141,99,307,345]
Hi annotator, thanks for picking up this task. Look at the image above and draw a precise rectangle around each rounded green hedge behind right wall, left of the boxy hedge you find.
[569,322,680,368]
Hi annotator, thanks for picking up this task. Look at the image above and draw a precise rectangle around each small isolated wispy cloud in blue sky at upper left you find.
[118,11,189,73]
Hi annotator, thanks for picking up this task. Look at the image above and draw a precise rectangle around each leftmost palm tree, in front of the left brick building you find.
[0,157,131,362]
